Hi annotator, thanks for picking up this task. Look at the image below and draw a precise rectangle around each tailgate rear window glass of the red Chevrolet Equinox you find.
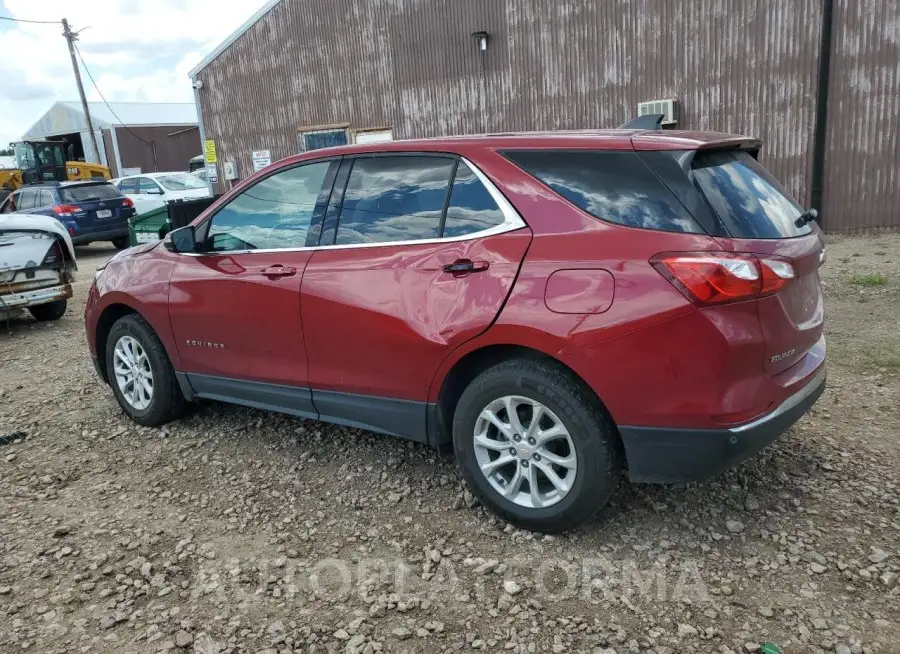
[693,150,812,238]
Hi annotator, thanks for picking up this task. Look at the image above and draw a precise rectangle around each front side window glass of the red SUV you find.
[204,161,332,252]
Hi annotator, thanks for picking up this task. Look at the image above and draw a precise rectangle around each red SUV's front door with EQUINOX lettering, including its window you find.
[169,156,339,416]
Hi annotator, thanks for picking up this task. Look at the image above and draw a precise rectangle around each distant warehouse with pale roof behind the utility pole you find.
[23,102,201,177]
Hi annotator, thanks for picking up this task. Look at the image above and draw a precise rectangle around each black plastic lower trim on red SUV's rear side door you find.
[312,390,428,443]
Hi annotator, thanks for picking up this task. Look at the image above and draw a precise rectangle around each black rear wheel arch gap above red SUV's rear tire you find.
[428,343,621,446]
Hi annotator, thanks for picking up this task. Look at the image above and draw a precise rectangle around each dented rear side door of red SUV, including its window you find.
[301,153,531,440]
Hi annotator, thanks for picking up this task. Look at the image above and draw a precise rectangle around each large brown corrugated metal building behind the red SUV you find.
[191,0,900,231]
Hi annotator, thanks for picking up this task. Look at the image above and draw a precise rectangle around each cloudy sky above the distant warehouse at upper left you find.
[0,0,265,147]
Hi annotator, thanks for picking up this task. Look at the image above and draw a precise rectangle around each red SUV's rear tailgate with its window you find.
[692,150,825,375]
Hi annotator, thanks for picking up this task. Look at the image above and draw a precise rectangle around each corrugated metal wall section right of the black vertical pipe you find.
[823,0,900,231]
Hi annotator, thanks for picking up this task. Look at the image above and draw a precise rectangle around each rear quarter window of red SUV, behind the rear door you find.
[504,150,703,233]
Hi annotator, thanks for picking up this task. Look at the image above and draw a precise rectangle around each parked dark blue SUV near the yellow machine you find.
[0,180,135,250]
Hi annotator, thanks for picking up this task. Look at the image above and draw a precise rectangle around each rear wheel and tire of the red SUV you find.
[453,360,622,533]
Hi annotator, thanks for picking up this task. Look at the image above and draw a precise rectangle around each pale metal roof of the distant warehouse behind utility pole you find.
[23,102,197,139]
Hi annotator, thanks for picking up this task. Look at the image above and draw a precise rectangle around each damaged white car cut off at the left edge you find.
[0,213,77,321]
